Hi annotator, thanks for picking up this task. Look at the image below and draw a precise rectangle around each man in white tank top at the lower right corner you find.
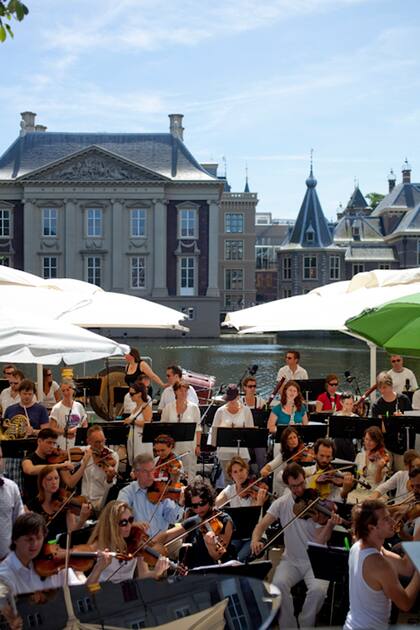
[344,500,420,630]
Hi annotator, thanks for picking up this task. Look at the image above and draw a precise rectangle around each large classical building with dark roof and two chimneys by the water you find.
[0,112,223,336]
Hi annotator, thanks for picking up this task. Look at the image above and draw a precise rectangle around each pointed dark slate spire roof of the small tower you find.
[283,167,332,248]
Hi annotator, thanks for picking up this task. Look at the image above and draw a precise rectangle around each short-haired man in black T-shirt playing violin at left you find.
[22,428,74,502]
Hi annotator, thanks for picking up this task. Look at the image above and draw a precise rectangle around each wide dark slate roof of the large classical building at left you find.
[0,132,217,182]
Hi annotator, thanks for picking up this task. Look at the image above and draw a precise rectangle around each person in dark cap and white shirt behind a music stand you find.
[210,384,254,476]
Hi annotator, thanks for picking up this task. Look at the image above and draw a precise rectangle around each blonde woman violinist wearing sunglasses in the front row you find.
[88,501,168,583]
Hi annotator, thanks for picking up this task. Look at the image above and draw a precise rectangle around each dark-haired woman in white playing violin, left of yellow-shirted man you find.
[261,426,315,496]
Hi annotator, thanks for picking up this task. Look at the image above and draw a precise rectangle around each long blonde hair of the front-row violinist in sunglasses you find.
[88,501,133,553]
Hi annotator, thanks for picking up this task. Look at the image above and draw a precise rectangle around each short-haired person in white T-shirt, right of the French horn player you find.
[50,378,87,449]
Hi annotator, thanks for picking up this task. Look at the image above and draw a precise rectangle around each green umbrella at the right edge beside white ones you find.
[346,293,420,356]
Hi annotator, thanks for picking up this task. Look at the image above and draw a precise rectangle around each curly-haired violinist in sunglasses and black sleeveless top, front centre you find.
[165,481,235,569]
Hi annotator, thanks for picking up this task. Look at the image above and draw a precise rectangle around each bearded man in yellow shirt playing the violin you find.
[305,438,353,502]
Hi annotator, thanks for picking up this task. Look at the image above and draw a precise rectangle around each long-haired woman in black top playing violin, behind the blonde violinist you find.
[28,466,91,540]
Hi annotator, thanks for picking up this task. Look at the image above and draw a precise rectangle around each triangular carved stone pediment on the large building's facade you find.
[19,146,168,184]
